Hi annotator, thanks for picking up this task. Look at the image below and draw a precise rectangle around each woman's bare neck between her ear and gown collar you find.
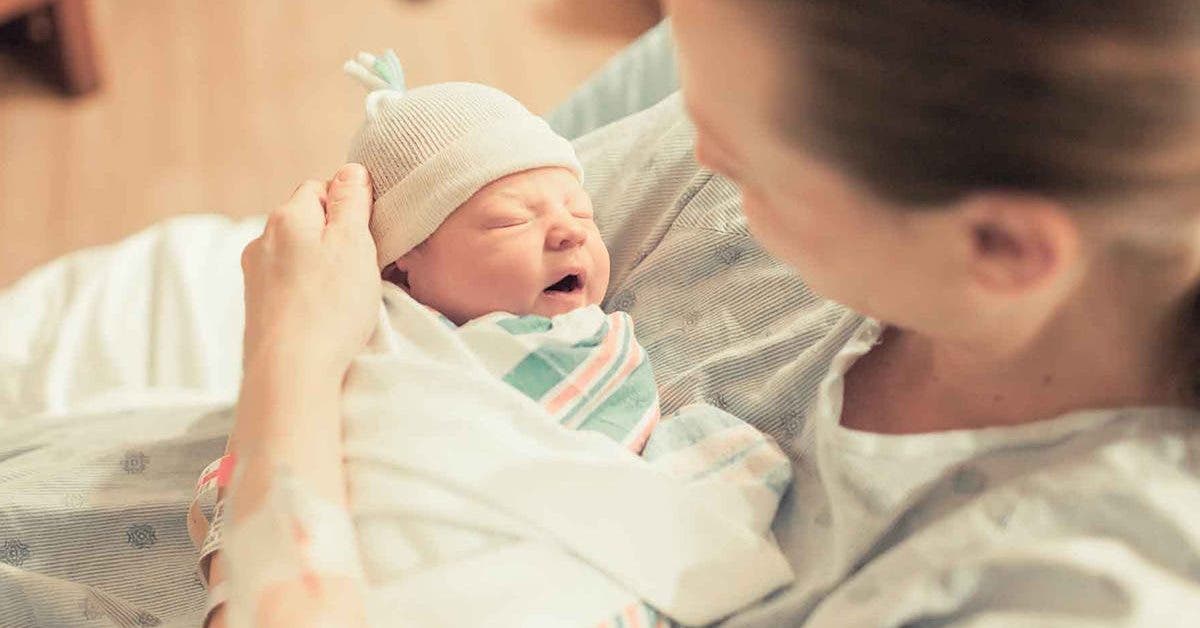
[842,253,1196,433]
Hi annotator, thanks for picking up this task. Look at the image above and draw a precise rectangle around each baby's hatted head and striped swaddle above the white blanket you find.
[347,49,659,453]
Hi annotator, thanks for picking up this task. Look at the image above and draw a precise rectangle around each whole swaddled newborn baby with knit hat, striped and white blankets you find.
[216,50,792,627]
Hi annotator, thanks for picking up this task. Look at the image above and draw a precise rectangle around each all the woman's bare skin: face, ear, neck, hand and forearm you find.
[215,0,1200,626]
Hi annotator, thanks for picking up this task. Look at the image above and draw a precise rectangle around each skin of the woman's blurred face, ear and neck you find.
[668,0,1200,433]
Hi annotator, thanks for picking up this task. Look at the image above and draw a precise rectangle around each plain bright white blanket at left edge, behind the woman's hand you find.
[0,215,264,424]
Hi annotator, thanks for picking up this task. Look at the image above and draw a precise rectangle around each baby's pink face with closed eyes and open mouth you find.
[396,168,608,324]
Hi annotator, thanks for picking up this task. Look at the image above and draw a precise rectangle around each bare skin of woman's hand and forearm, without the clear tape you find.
[210,163,380,628]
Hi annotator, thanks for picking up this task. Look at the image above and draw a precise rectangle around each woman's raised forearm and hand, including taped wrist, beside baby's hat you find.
[210,163,379,626]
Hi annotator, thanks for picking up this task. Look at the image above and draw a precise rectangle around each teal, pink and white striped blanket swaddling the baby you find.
[444,297,791,628]
